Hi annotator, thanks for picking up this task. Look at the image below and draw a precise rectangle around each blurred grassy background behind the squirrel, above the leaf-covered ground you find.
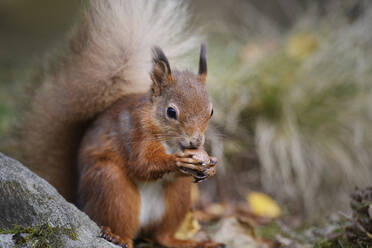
[0,0,372,231]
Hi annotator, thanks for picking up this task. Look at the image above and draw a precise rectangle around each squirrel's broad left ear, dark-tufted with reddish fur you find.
[151,47,172,95]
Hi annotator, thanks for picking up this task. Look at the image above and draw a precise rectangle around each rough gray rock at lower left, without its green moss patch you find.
[0,153,118,248]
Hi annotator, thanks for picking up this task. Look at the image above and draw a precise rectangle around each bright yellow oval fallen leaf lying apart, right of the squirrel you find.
[247,192,281,218]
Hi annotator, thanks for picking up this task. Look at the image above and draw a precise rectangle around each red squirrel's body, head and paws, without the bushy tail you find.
[78,46,222,247]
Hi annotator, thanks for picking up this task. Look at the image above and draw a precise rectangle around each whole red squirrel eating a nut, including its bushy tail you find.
[16,0,224,248]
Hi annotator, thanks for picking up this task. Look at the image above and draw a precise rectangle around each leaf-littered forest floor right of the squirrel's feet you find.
[136,187,372,248]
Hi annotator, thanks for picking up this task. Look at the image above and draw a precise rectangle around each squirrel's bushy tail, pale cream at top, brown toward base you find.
[20,0,200,201]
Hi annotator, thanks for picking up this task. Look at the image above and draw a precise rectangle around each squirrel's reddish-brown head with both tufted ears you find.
[151,44,213,151]
